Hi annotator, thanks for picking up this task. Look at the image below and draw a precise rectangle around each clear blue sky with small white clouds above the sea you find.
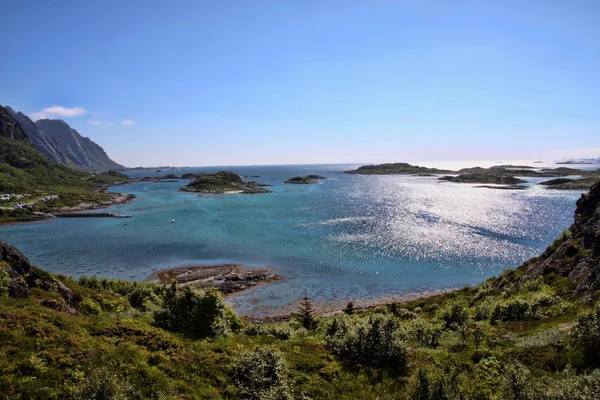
[0,0,600,166]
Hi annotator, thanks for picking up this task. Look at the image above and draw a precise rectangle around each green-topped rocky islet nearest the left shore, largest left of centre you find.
[179,171,271,194]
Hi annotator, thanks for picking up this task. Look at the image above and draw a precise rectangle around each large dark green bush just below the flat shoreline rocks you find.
[154,283,241,338]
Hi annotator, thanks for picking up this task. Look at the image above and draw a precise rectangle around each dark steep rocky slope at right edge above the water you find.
[499,181,600,294]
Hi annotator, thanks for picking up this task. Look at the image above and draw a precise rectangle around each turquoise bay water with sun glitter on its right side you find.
[0,166,579,313]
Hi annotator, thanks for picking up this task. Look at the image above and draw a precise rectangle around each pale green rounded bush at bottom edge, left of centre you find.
[232,347,292,400]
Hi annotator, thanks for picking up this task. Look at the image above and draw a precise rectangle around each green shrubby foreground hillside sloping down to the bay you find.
[0,177,600,400]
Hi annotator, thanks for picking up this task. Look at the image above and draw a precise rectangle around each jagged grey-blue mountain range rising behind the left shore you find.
[0,106,124,172]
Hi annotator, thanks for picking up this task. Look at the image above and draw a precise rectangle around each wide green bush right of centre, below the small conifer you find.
[326,314,408,373]
